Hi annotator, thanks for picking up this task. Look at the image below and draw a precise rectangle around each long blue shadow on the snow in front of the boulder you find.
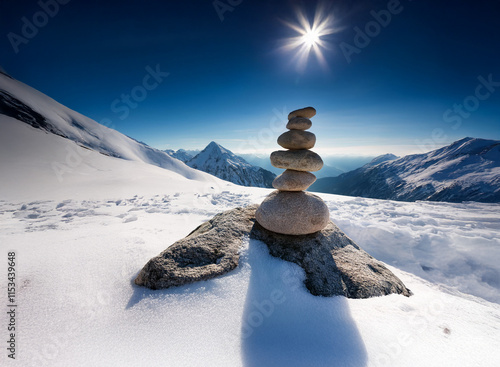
[241,239,367,367]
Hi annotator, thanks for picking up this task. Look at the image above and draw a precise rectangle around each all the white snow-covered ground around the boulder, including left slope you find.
[0,117,500,367]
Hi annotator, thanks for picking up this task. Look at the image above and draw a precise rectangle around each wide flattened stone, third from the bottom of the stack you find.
[271,149,323,172]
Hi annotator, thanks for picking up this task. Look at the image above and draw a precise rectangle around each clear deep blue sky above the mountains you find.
[0,0,500,155]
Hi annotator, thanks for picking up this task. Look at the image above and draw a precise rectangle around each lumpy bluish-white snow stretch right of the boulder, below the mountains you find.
[320,195,500,303]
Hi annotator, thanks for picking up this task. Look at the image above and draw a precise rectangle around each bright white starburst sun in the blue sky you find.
[280,6,340,71]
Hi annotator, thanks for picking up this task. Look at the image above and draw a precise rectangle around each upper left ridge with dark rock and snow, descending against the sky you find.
[0,74,203,179]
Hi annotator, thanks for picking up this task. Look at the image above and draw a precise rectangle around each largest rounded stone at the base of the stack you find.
[255,191,330,235]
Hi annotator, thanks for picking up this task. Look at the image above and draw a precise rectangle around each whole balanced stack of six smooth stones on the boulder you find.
[255,107,330,235]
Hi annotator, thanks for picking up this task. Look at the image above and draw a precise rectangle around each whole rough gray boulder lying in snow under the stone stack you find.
[135,205,411,298]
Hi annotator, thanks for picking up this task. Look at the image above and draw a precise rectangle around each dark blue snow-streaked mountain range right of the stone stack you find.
[310,138,500,203]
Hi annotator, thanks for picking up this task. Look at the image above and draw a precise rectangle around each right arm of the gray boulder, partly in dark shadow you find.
[250,221,411,298]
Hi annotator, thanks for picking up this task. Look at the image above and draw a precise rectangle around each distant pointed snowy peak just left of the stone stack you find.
[185,141,276,188]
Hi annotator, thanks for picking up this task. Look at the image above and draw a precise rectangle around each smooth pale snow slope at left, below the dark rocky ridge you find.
[0,115,234,200]
